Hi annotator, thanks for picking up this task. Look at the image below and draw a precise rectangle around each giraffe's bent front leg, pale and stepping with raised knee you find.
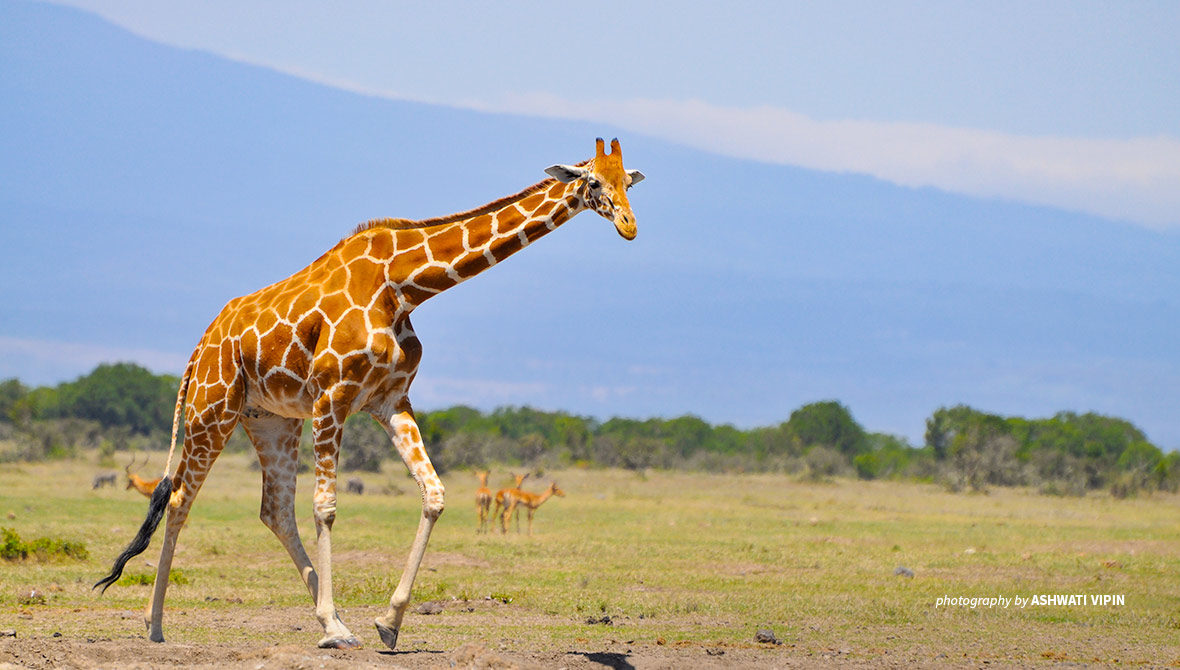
[373,405,445,649]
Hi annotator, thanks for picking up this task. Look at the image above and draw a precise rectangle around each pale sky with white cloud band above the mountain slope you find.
[41,0,1180,229]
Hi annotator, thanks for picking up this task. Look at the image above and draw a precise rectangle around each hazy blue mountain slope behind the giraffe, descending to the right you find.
[0,1,1180,447]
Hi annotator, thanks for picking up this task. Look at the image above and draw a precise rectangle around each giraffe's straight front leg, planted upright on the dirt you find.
[308,403,361,649]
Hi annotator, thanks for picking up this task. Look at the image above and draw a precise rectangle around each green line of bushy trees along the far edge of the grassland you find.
[0,363,1180,497]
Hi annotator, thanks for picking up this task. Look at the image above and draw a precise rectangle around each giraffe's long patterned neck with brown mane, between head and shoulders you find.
[388,180,585,306]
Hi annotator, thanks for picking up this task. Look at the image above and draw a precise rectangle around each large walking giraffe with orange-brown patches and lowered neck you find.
[94,138,643,649]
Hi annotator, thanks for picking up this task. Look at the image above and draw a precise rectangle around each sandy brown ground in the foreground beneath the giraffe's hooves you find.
[0,607,1014,670]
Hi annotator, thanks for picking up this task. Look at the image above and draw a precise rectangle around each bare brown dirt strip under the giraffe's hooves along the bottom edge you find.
[0,600,1110,670]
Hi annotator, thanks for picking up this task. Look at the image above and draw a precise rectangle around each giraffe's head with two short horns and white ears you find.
[545,137,643,239]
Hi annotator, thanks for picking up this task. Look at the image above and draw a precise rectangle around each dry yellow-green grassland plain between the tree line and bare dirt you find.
[0,454,1180,666]
